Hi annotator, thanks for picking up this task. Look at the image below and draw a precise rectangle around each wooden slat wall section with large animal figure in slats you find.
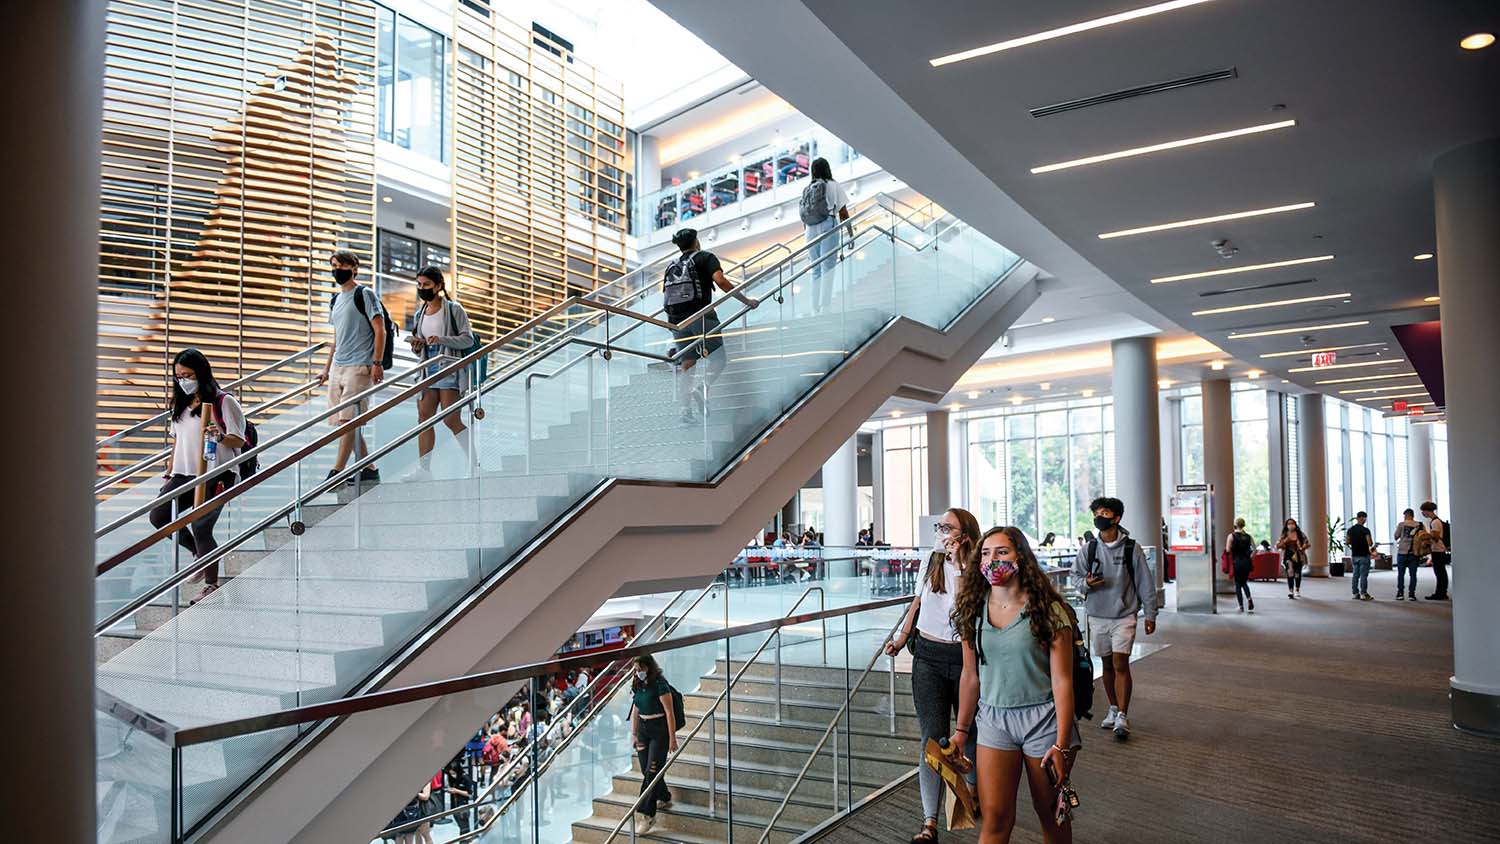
[99,0,375,472]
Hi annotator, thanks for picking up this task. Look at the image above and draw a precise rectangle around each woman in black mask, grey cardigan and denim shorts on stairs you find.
[401,267,474,481]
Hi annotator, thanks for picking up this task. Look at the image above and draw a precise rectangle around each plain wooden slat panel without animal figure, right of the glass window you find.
[452,3,626,347]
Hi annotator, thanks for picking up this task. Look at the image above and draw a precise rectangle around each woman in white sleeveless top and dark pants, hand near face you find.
[885,508,980,844]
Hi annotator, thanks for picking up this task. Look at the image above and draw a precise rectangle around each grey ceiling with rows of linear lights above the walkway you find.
[654,0,1500,413]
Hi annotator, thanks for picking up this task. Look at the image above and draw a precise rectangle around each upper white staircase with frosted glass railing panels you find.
[98,193,1017,841]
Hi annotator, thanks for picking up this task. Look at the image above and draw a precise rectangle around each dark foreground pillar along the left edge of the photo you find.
[0,0,101,841]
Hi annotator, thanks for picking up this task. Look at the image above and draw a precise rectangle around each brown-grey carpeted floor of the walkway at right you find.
[822,571,1500,844]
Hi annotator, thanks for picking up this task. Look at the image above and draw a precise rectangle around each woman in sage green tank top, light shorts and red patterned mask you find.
[950,528,1082,844]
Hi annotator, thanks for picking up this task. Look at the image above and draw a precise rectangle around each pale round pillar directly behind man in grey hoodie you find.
[1110,337,1166,585]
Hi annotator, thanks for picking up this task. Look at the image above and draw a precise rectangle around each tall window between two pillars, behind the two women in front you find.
[963,399,1115,541]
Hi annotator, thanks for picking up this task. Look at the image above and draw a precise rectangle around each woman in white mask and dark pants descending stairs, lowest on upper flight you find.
[149,349,245,603]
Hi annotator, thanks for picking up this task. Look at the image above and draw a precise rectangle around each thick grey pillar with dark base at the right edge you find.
[1416,138,1500,738]
